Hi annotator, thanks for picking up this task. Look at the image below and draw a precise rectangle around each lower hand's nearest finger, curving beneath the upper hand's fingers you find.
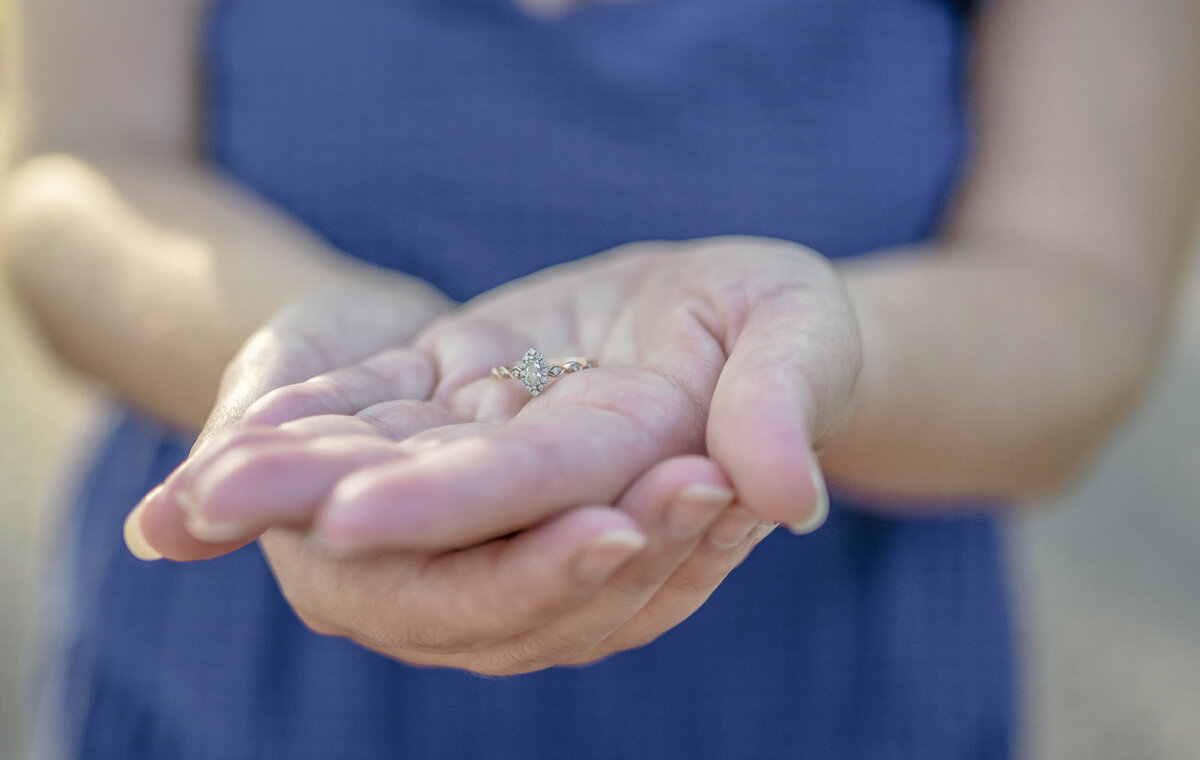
[264,507,646,662]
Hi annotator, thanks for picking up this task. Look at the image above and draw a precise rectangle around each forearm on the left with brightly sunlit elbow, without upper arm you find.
[0,155,451,429]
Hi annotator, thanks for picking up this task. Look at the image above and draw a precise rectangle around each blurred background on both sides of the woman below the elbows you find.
[0,232,1200,760]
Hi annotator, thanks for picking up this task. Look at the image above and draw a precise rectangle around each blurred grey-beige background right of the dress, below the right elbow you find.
[1014,234,1200,760]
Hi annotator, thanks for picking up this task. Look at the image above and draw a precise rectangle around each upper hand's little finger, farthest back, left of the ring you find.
[242,348,434,425]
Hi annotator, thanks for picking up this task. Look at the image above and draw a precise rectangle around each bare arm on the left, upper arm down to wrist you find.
[0,0,440,427]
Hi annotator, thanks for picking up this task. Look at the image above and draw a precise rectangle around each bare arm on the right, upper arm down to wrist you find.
[823,0,1200,498]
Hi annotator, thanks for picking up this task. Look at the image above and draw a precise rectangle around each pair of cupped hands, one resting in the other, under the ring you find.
[126,238,859,672]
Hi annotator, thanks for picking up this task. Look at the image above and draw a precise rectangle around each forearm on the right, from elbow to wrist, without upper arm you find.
[822,241,1169,503]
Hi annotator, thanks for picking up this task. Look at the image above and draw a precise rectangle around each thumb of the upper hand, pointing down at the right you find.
[708,264,862,532]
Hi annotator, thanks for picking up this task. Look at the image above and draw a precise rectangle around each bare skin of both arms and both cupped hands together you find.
[0,0,1200,674]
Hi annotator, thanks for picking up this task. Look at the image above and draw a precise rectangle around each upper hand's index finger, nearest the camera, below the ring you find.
[314,370,701,549]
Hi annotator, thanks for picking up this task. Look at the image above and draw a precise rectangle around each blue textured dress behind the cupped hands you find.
[43,0,1013,760]
